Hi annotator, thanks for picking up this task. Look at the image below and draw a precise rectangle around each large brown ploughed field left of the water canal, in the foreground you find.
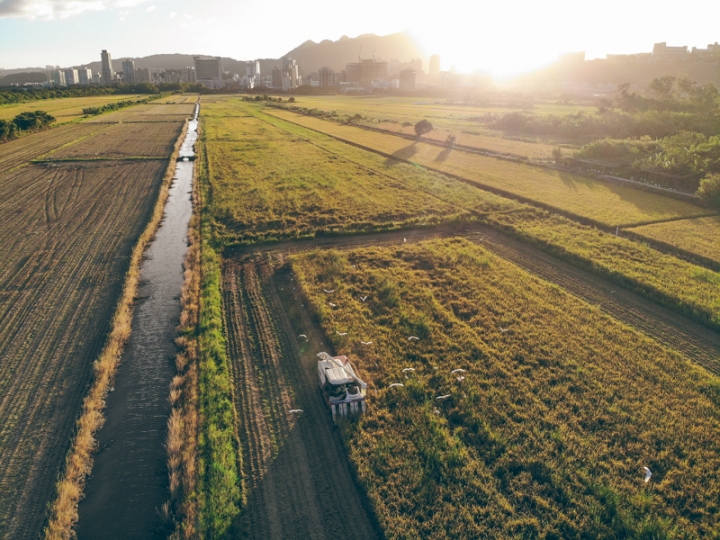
[0,158,167,538]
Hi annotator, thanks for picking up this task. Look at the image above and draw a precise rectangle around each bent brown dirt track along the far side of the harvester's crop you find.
[229,221,720,375]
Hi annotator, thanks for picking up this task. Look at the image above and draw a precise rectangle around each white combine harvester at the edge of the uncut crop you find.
[318,352,367,424]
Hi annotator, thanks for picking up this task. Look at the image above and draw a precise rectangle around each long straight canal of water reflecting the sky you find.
[77,105,198,540]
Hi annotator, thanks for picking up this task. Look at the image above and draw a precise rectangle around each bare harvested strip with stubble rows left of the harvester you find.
[223,261,377,539]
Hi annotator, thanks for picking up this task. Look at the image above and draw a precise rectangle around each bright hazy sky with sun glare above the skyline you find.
[0,0,720,77]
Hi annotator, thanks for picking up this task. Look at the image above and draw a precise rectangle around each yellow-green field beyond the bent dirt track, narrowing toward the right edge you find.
[207,99,720,329]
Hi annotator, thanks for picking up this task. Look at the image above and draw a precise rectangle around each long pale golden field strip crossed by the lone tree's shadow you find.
[266,109,708,227]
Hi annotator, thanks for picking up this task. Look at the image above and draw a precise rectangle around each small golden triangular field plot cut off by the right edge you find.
[629,217,720,264]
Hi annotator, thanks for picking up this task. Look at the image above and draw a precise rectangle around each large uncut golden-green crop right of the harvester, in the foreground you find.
[291,240,720,538]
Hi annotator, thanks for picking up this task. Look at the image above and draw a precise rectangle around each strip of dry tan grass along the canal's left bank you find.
[44,120,188,540]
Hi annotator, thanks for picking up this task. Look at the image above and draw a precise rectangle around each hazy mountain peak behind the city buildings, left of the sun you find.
[285,32,425,75]
